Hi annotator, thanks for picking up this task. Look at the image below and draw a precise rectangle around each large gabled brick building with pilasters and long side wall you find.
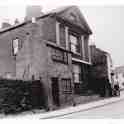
[0,6,92,108]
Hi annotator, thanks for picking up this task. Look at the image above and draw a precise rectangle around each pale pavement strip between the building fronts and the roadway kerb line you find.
[0,91,124,119]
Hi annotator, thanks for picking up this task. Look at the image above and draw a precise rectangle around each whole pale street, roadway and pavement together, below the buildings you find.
[0,91,124,119]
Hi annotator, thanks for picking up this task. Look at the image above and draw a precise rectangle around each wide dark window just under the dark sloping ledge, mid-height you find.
[52,49,68,64]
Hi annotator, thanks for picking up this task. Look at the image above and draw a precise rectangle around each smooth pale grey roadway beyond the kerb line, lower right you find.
[53,93,124,119]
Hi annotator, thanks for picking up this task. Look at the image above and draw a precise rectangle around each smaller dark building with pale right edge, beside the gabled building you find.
[90,45,114,96]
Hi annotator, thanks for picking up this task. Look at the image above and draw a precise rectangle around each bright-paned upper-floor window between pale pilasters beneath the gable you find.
[69,34,80,54]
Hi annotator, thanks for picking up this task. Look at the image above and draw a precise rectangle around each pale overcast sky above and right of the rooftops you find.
[0,0,124,66]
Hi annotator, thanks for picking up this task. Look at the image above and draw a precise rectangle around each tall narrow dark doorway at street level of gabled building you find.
[52,78,60,106]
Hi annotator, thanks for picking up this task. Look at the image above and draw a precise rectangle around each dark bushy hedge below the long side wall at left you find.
[0,79,43,114]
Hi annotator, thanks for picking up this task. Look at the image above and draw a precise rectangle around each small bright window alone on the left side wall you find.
[12,38,22,56]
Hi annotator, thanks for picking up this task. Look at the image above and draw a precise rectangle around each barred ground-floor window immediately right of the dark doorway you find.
[61,79,72,93]
